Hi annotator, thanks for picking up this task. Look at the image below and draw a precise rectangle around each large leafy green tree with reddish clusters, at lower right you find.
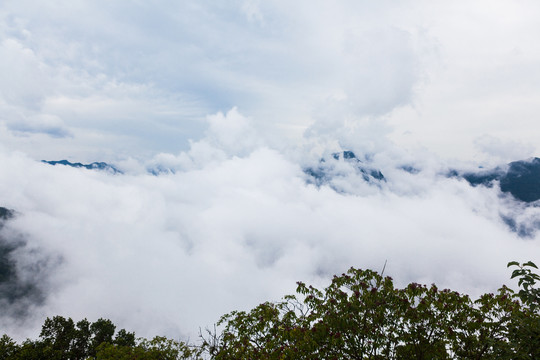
[203,263,540,359]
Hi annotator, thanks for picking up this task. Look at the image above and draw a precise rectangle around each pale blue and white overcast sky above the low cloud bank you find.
[0,0,540,159]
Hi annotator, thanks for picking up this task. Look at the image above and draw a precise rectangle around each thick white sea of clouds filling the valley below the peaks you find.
[0,125,539,338]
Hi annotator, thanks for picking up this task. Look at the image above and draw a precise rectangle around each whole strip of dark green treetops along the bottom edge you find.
[0,262,540,360]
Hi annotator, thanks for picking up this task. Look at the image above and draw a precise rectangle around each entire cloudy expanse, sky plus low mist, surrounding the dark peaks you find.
[0,0,540,337]
